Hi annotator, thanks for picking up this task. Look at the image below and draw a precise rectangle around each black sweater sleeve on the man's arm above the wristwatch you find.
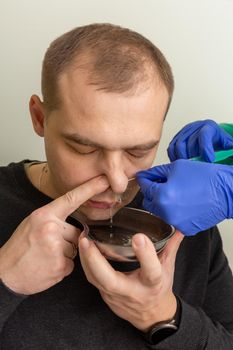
[141,227,233,350]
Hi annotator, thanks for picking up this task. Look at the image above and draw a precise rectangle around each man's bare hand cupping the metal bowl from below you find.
[79,231,183,331]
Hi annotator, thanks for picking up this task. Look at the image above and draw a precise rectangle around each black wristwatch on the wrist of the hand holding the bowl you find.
[144,298,181,345]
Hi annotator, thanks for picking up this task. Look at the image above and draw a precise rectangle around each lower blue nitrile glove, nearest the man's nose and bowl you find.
[137,159,233,236]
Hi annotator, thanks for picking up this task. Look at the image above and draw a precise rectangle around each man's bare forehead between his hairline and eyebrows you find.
[55,70,168,144]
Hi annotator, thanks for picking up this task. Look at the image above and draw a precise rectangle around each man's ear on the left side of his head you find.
[29,95,45,137]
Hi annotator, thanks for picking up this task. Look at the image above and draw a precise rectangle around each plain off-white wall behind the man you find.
[0,0,233,267]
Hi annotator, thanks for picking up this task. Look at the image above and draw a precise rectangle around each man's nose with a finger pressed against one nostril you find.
[101,151,128,194]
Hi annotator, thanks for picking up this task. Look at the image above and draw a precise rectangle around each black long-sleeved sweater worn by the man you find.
[0,162,233,350]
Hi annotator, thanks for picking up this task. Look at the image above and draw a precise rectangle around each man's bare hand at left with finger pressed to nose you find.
[0,176,109,294]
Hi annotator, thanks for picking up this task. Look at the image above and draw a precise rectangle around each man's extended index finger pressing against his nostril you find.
[45,176,109,220]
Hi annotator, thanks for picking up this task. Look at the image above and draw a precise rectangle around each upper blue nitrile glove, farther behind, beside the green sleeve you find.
[167,119,233,162]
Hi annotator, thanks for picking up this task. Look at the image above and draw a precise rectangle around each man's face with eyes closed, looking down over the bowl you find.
[40,69,168,220]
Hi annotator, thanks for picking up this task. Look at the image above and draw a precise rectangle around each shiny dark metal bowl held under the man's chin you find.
[85,207,175,261]
